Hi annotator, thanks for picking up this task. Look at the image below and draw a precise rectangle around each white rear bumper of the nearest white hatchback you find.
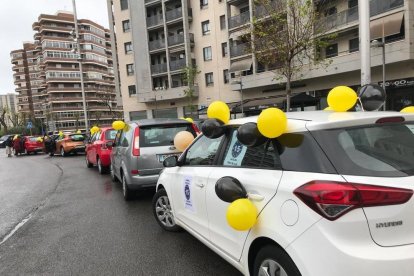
[286,216,414,276]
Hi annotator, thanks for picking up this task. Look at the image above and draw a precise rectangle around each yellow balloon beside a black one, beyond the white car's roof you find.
[328,86,358,112]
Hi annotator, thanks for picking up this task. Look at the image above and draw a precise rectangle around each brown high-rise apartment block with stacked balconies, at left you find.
[11,12,120,131]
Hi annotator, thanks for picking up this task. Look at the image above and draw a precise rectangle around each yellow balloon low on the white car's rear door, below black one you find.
[226,198,257,231]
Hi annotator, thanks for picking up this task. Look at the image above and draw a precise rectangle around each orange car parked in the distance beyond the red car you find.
[54,133,86,157]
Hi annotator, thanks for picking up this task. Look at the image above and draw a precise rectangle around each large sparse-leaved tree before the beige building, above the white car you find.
[250,0,335,111]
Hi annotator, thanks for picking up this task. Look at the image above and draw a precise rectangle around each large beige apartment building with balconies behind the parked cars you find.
[109,0,414,119]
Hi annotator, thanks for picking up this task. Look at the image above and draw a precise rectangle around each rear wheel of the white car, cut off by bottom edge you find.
[253,245,301,276]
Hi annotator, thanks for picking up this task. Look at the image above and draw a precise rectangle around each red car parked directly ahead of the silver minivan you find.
[85,127,117,174]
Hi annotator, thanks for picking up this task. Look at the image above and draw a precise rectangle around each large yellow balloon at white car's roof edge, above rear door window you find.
[257,107,287,138]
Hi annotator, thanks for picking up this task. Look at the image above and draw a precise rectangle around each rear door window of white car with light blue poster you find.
[222,129,281,169]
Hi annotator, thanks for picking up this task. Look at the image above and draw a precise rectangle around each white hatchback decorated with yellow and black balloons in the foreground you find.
[153,111,414,276]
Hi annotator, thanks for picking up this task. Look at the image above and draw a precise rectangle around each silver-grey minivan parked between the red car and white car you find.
[110,119,198,200]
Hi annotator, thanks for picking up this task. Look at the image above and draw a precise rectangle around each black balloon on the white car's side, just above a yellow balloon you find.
[215,176,247,203]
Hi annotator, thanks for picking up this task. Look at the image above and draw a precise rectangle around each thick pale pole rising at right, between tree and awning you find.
[358,0,371,86]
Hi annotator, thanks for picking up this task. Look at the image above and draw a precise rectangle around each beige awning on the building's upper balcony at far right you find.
[370,11,404,40]
